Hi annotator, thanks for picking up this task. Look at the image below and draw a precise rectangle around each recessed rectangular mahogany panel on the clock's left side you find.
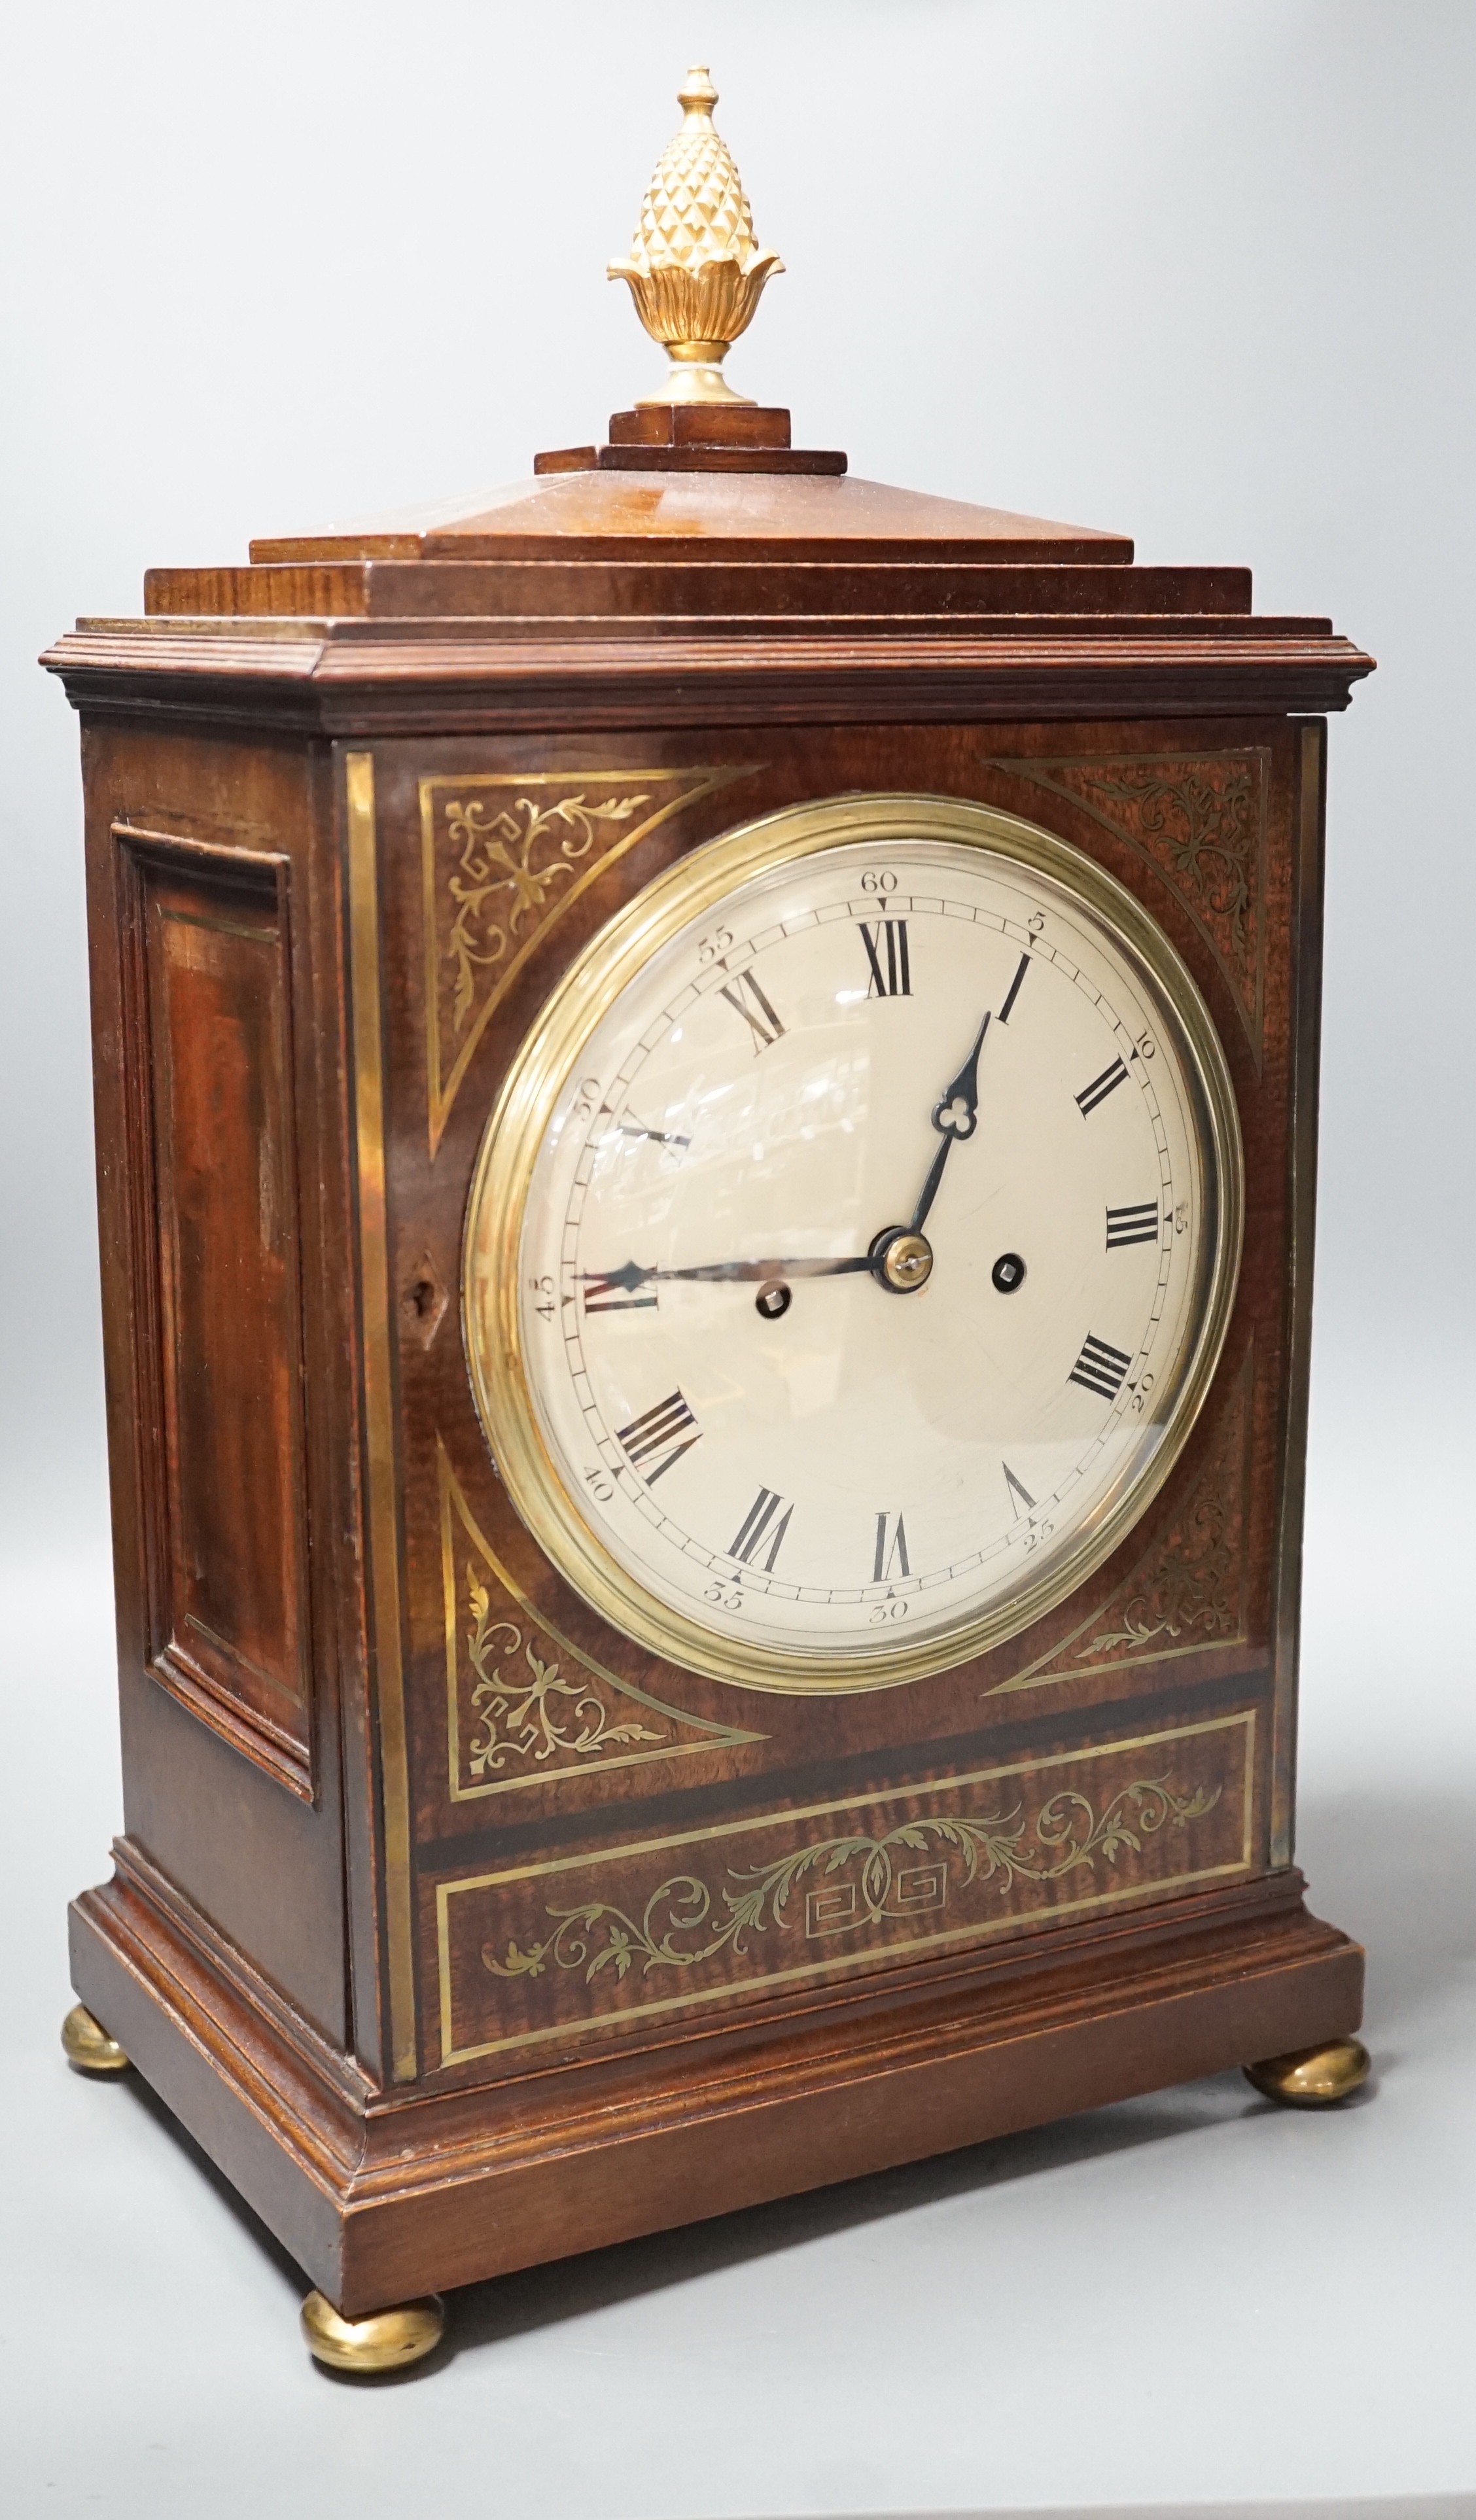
[113,826,312,1796]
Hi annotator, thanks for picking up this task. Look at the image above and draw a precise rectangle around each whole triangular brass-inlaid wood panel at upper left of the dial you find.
[421,766,746,1154]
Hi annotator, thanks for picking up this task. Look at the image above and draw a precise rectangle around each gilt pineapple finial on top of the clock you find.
[610,65,783,403]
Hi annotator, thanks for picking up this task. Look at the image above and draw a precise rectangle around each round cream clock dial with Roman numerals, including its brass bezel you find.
[466,799,1239,1689]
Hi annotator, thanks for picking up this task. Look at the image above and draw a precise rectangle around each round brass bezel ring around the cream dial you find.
[461,794,1244,1696]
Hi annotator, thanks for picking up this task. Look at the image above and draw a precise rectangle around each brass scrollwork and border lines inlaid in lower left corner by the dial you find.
[436,1437,768,1802]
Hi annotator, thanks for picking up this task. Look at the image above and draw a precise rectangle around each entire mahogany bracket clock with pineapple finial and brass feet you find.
[48,71,1370,2369]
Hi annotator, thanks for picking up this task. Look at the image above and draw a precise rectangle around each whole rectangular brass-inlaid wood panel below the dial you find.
[436,1709,1254,2064]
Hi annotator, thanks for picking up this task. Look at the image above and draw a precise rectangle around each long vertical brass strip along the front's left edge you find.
[343,754,418,2082]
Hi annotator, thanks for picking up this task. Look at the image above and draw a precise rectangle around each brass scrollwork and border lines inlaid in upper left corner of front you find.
[421,761,758,1154]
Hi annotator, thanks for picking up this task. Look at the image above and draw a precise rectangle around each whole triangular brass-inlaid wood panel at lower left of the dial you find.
[436,1444,763,1802]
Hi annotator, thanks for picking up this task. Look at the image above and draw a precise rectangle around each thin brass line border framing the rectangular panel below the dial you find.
[436,1706,1257,2067]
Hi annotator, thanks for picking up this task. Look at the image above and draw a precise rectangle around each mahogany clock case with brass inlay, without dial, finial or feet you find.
[48,453,1370,2313]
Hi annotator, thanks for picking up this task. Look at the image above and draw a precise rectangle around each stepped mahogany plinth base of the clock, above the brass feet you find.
[73,1845,1363,2318]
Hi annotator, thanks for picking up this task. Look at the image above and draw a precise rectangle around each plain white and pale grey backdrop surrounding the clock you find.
[0,0,1476,2520]
